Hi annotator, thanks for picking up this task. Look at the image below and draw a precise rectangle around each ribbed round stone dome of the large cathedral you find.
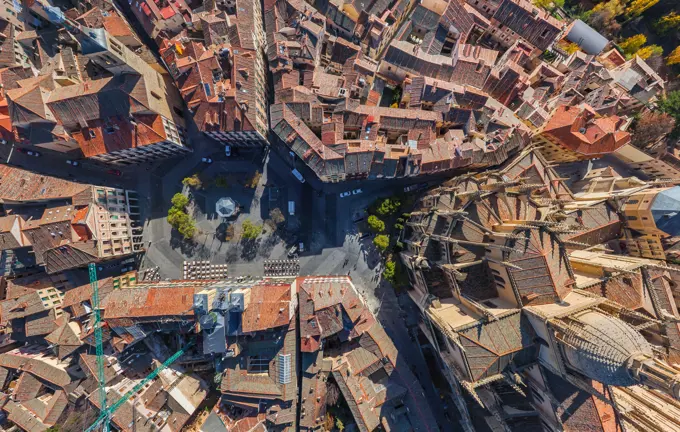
[560,311,653,386]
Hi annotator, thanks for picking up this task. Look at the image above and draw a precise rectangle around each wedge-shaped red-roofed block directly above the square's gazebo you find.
[161,0,268,147]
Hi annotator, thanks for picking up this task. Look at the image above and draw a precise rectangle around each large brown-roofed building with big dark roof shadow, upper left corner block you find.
[6,20,191,165]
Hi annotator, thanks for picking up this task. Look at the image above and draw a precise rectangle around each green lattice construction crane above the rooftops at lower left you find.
[86,263,194,432]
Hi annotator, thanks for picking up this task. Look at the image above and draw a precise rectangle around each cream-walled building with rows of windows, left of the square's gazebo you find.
[0,166,142,273]
